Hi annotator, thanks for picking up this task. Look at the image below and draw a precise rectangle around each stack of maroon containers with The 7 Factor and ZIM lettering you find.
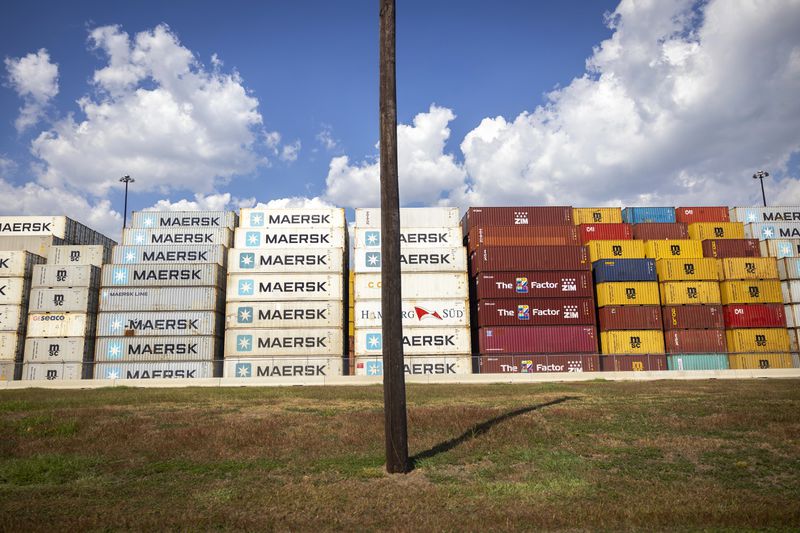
[462,207,596,373]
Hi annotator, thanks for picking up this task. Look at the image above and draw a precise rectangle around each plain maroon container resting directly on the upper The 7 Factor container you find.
[469,246,592,276]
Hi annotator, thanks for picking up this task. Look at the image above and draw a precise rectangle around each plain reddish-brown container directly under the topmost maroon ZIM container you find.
[467,226,580,252]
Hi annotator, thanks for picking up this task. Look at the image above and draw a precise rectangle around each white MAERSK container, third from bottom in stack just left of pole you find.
[225,300,344,329]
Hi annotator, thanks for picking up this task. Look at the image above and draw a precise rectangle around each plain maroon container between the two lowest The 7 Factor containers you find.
[478,326,597,355]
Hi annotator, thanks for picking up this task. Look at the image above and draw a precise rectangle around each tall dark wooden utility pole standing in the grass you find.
[379,0,410,474]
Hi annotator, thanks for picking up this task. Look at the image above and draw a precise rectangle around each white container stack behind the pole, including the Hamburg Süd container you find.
[353,207,472,376]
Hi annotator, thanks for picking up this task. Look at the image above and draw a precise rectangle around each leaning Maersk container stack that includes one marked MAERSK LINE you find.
[94,211,236,379]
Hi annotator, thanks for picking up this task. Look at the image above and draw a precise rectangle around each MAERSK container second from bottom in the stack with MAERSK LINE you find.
[94,335,222,362]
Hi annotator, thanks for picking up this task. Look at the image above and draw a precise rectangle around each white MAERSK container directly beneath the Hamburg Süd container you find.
[354,327,471,356]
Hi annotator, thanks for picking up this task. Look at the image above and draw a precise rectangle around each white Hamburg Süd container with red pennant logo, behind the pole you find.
[351,299,468,328]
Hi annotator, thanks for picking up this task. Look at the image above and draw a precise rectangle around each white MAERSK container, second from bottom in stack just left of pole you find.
[225,327,344,357]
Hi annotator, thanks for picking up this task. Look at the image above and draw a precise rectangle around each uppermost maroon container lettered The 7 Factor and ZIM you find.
[472,270,594,300]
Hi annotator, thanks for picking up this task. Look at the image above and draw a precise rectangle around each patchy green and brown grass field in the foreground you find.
[0,380,800,531]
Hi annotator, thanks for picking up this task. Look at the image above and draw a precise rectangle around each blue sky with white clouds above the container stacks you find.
[0,0,800,237]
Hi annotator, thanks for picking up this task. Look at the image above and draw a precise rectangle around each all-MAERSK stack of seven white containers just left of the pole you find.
[225,208,348,381]
